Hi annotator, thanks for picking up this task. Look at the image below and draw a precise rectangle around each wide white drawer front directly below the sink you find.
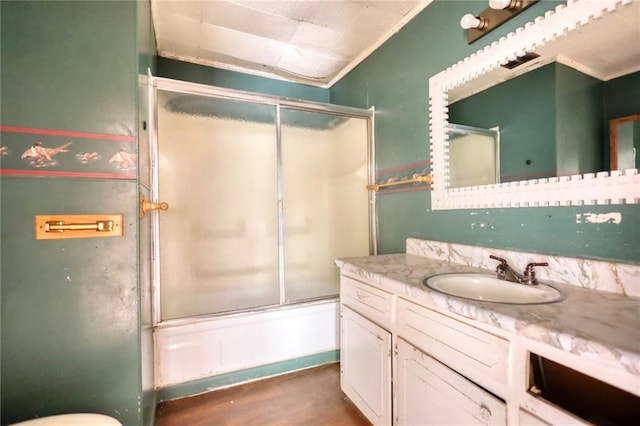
[398,299,509,394]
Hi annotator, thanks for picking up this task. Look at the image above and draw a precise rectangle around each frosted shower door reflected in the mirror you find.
[449,123,500,188]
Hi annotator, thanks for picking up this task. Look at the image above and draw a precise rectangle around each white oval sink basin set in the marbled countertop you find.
[423,273,564,305]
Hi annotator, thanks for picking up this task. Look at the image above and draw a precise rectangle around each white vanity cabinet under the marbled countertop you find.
[340,275,640,426]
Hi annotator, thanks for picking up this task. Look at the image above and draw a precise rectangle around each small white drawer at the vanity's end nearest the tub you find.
[340,275,393,326]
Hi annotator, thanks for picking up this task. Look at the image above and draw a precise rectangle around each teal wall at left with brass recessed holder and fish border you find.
[0,1,155,425]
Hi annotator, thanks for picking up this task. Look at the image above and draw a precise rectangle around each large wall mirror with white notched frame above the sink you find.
[429,0,640,209]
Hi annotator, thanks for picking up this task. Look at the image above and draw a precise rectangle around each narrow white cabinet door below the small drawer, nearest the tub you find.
[340,305,391,426]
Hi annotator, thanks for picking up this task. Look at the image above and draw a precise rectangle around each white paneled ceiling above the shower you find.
[151,0,432,87]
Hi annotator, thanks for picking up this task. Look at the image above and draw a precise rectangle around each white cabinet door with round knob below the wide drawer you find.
[395,339,506,426]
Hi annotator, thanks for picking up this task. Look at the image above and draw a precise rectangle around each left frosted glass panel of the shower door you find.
[158,90,279,321]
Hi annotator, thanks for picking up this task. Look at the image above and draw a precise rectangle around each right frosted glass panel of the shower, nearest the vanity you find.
[281,109,369,303]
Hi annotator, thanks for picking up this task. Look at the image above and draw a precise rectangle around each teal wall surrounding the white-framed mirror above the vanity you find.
[331,0,640,262]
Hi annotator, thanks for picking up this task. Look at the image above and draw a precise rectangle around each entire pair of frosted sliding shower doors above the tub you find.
[154,80,371,322]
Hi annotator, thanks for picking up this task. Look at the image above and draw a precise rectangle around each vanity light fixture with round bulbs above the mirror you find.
[460,0,540,44]
